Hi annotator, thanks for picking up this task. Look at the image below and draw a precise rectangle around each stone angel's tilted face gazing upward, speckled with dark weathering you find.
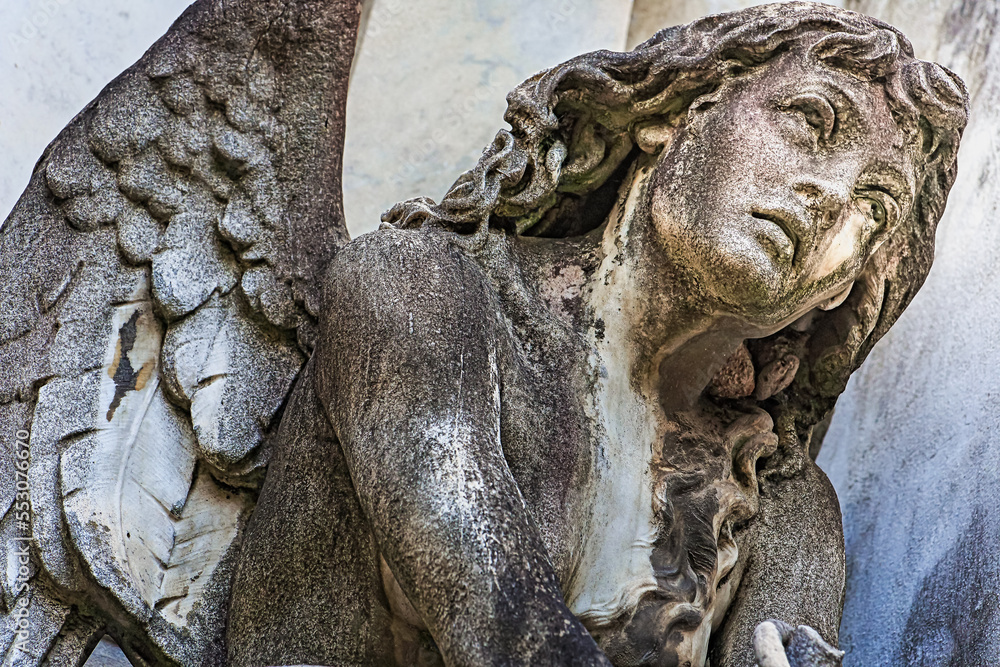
[652,43,919,326]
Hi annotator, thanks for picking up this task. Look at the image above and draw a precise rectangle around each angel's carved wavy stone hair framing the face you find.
[383,2,967,436]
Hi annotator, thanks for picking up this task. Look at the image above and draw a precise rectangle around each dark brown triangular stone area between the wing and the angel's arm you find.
[228,367,395,666]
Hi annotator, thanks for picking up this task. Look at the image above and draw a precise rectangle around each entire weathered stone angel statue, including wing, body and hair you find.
[0,0,967,667]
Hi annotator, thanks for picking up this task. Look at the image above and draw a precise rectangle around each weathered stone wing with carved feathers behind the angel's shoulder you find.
[0,0,359,665]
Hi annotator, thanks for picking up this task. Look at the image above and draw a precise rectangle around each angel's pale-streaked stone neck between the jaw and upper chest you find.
[505,167,748,409]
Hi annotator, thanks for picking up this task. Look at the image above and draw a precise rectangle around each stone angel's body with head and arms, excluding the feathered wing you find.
[236,5,965,667]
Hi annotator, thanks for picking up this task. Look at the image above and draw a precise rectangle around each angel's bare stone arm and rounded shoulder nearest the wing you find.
[317,230,609,665]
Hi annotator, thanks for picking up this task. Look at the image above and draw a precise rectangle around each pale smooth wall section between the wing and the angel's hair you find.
[344,0,632,233]
